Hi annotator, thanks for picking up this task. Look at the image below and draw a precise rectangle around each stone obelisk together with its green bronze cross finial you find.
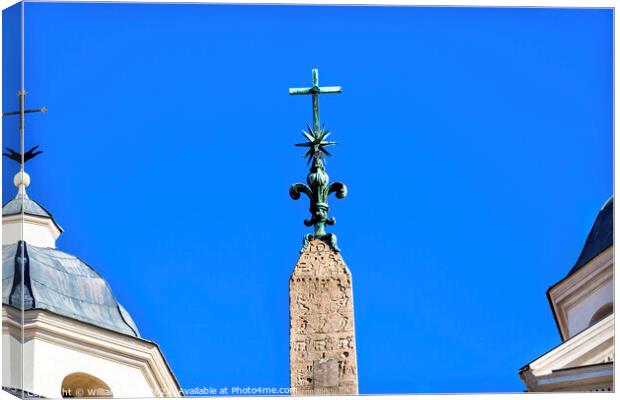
[289,69,358,395]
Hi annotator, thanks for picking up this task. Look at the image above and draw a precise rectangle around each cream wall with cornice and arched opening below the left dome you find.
[2,305,179,398]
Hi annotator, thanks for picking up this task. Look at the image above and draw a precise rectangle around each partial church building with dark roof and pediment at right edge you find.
[519,197,614,392]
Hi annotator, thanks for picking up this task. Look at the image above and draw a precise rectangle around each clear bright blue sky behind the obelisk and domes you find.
[2,3,613,394]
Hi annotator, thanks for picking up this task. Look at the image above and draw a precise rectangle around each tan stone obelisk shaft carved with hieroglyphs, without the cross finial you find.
[289,239,358,395]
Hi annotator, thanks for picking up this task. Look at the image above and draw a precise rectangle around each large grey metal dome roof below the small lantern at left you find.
[2,241,140,337]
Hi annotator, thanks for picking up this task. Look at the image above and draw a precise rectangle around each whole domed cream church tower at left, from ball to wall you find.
[2,173,182,398]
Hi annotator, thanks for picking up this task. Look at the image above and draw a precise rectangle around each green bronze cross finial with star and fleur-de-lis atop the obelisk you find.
[288,69,347,251]
